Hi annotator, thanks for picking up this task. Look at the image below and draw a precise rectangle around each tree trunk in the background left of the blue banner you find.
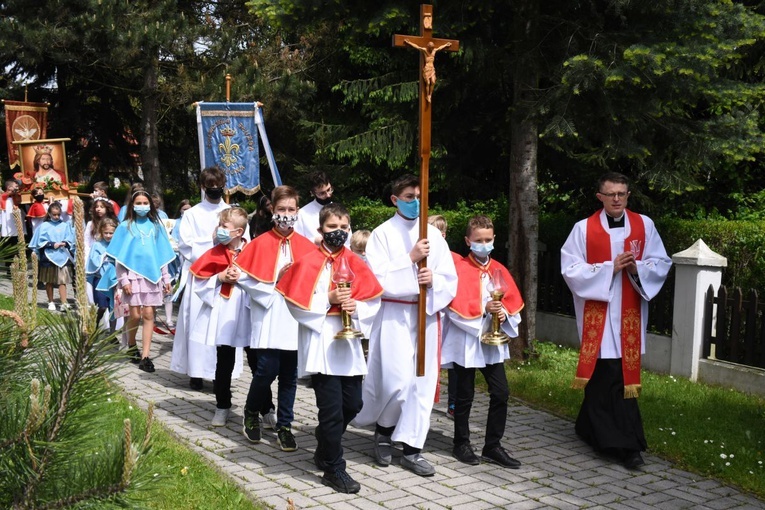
[141,49,162,195]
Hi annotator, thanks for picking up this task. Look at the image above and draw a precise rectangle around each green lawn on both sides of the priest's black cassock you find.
[507,343,765,498]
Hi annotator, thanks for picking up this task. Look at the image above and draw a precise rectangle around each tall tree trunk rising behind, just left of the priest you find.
[508,0,539,359]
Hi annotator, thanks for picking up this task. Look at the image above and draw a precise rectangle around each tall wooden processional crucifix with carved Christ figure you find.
[393,4,460,377]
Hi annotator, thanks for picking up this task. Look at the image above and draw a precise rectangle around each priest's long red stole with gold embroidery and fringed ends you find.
[572,209,645,398]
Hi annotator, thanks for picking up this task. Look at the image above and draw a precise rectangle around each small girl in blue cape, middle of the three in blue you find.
[85,217,117,331]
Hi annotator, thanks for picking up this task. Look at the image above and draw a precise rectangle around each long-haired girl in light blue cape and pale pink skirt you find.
[106,189,175,372]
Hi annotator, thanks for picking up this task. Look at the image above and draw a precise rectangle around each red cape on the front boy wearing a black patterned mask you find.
[276,246,383,315]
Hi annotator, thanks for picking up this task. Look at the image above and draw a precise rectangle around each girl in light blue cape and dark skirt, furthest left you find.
[29,202,74,311]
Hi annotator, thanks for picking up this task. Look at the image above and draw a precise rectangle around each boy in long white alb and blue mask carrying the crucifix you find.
[356,175,457,476]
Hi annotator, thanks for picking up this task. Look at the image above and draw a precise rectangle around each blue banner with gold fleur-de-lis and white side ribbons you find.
[197,102,281,195]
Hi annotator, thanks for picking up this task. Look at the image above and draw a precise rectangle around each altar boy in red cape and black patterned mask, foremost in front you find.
[276,203,383,494]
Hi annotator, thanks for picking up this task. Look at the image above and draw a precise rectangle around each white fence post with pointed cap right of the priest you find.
[670,239,728,381]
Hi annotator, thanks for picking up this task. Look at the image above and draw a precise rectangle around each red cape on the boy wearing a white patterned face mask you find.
[236,228,316,283]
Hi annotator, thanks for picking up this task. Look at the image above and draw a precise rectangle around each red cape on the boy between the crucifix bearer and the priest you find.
[449,252,524,319]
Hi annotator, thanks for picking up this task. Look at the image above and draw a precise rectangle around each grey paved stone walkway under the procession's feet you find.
[0,275,765,510]
